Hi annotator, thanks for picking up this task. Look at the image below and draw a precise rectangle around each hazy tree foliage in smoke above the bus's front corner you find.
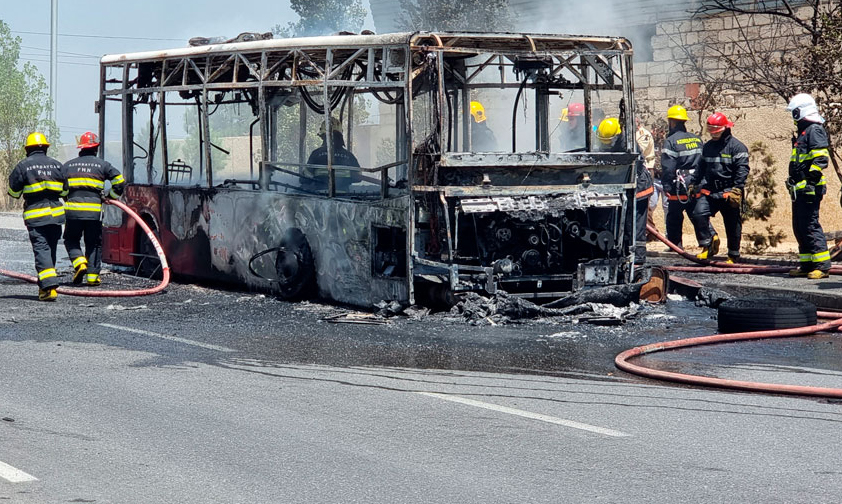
[398,0,512,31]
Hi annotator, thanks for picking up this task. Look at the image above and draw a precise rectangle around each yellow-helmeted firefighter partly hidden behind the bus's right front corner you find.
[596,117,655,264]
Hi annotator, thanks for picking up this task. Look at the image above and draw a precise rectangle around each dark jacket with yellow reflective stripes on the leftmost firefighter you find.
[8,151,65,227]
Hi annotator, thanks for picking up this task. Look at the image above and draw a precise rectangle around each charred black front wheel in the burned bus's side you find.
[275,228,316,301]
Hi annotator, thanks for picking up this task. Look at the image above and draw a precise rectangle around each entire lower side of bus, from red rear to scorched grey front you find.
[104,185,409,307]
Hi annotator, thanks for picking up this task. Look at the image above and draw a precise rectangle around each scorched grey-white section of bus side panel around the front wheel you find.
[205,189,409,306]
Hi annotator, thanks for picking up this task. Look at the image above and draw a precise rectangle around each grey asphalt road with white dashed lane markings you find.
[0,225,842,503]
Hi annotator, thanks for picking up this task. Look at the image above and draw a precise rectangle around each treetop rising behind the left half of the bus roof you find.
[272,0,367,37]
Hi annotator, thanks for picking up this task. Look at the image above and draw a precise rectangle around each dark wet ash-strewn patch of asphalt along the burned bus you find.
[37,273,716,375]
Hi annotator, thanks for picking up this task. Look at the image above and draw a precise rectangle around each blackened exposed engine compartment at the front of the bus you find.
[410,191,624,298]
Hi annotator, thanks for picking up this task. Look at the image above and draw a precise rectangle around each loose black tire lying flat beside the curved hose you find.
[718,297,816,333]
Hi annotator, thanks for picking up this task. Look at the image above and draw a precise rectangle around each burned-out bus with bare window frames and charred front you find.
[97,32,639,306]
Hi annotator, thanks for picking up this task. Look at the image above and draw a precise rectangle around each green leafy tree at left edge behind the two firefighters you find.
[0,21,58,208]
